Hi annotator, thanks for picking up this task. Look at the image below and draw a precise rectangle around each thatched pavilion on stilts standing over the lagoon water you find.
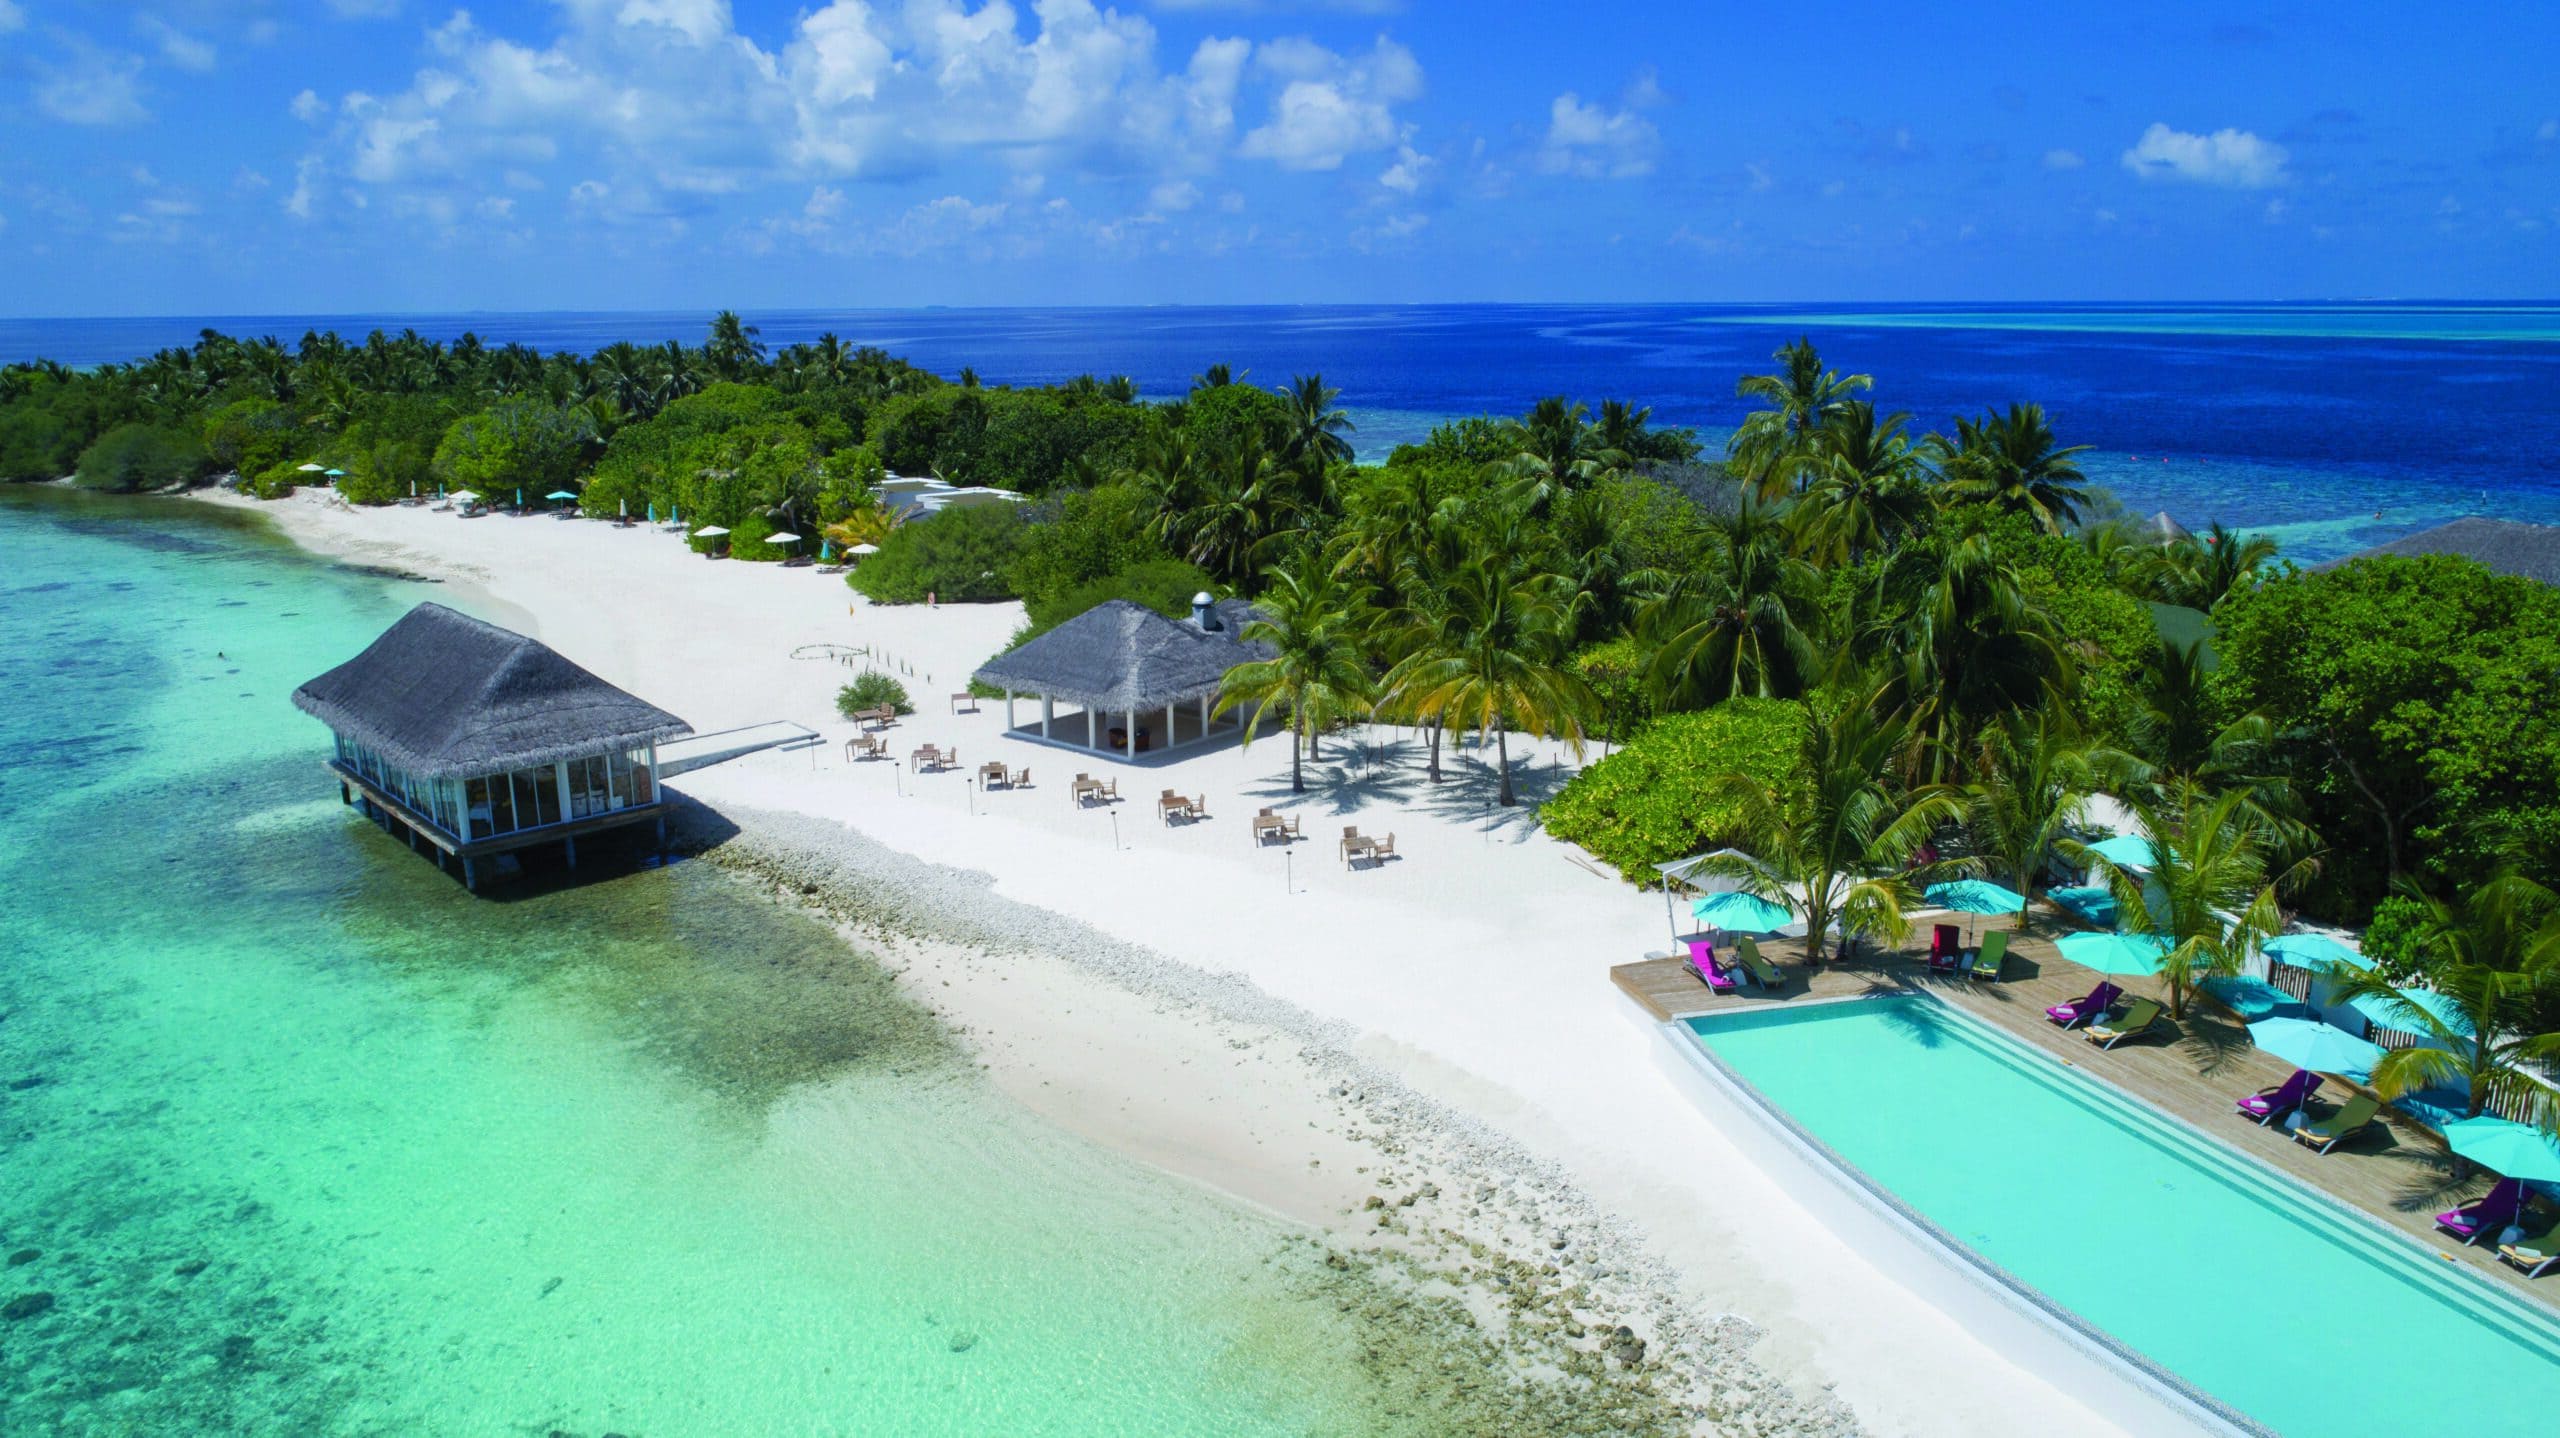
[294,604,694,888]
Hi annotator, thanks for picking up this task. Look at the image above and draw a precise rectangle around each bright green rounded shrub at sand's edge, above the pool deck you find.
[1539,699,1805,883]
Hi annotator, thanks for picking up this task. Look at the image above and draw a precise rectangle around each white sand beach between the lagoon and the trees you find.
[218,494,2184,1435]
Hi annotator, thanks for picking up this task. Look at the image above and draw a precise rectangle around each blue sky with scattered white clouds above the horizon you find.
[0,0,2560,315]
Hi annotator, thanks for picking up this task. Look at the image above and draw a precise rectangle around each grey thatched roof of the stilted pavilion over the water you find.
[294,604,694,778]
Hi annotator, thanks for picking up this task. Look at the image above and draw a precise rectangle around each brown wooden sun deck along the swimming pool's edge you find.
[1610,924,2560,1308]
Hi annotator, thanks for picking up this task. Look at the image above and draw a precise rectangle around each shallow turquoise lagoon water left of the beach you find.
[0,494,1474,1435]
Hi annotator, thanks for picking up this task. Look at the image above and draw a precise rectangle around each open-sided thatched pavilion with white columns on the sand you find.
[975,594,1272,760]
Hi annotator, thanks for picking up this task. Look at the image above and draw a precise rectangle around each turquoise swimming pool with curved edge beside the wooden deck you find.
[1682,995,2560,1438]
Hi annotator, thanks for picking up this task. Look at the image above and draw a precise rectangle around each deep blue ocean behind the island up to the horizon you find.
[0,304,2560,563]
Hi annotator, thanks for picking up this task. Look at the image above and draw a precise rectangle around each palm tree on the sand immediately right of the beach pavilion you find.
[1216,563,1370,793]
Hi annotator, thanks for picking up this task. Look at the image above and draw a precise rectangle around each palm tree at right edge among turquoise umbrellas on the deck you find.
[2337,870,2560,1134]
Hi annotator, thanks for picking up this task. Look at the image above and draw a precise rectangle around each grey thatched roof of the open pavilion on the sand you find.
[975,599,1272,714]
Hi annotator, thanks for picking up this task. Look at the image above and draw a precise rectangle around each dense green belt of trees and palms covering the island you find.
[0,315,2560,951]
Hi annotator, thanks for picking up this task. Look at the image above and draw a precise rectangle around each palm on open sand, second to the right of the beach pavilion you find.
[1385,555,1597,809]
